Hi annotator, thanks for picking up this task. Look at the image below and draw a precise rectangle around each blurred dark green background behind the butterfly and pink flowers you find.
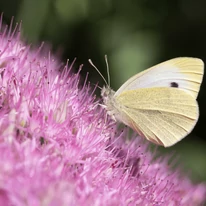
[0,0,206,182]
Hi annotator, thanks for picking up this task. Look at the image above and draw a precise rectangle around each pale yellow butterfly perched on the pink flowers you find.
[97,57,204,147]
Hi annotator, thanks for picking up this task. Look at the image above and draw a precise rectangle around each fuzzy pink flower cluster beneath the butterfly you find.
[0,17,206,206]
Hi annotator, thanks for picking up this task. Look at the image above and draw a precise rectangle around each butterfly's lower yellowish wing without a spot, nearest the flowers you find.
[115,87,199,147]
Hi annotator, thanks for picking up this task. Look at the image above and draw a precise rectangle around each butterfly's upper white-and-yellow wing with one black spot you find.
[115,57,204,98]
